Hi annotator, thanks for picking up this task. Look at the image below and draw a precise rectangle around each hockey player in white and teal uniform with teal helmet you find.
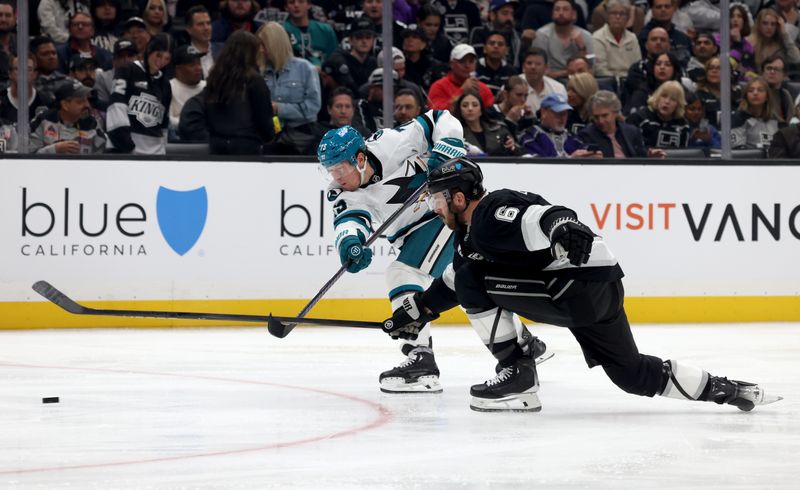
[317,110,544,393]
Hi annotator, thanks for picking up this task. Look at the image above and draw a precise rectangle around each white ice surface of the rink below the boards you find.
[0,324,800,489]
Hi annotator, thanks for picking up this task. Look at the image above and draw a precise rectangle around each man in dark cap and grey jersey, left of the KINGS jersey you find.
[30,82,106,154]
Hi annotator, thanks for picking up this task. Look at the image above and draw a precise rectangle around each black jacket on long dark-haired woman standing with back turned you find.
[206,77,275,155]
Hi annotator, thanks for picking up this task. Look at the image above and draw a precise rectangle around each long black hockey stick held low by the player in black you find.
[28,281,383,329]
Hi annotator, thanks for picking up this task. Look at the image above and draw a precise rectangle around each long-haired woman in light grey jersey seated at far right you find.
[731,78,781,148]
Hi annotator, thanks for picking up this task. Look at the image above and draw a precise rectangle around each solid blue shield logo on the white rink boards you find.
[156,186,208,255]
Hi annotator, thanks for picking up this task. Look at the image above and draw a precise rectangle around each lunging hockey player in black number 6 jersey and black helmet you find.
[384,159,781,411]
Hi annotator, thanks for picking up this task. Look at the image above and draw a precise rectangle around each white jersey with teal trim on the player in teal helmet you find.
[328,110,464,251]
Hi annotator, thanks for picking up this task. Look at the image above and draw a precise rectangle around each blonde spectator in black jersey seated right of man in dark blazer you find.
[627,80,689,148]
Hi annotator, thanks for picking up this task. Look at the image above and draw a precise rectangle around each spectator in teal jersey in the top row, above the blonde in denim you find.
[283,0,339,67]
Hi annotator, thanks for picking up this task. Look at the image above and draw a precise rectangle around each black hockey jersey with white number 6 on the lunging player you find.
[454,189,623,281]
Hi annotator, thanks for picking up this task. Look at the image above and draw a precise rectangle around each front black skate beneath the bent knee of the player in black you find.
[469,357,542,412]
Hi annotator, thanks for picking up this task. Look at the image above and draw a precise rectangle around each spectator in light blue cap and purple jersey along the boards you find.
[520,94,600,158]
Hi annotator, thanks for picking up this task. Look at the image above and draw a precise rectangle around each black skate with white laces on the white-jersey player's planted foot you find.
[379,345,442,393]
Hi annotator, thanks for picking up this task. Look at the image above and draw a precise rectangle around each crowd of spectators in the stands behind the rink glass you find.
[0,0,800,158]
